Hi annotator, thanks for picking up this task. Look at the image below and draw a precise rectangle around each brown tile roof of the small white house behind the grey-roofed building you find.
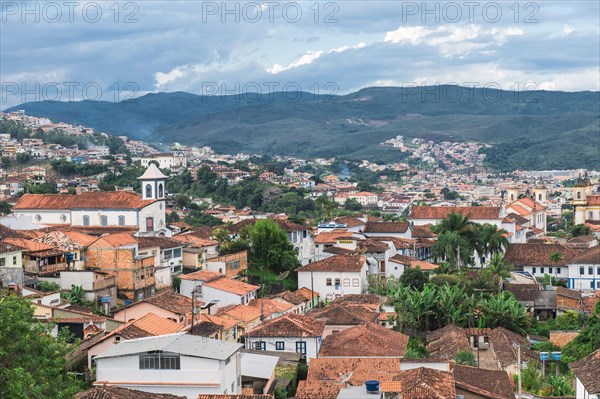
[248,313,325,337]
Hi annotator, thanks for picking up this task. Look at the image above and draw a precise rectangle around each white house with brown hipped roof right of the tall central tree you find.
[296,255,368,301]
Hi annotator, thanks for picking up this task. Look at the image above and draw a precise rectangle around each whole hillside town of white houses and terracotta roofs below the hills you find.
[0,111,600,399]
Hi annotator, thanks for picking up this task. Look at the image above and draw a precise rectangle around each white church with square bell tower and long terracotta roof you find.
[8,164,171,237]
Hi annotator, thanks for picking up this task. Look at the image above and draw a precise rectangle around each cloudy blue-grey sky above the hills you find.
[0,0,600,109]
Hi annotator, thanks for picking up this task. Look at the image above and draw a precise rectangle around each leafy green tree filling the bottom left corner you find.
[0,295,82,399]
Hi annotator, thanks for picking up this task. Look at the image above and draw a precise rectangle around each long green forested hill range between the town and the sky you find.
[9,86,600,170]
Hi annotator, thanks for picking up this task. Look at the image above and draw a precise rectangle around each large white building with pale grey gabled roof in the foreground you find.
[94,333,242,399]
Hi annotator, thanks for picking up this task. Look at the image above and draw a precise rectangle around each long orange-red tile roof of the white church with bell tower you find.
[13,191,156,210]
